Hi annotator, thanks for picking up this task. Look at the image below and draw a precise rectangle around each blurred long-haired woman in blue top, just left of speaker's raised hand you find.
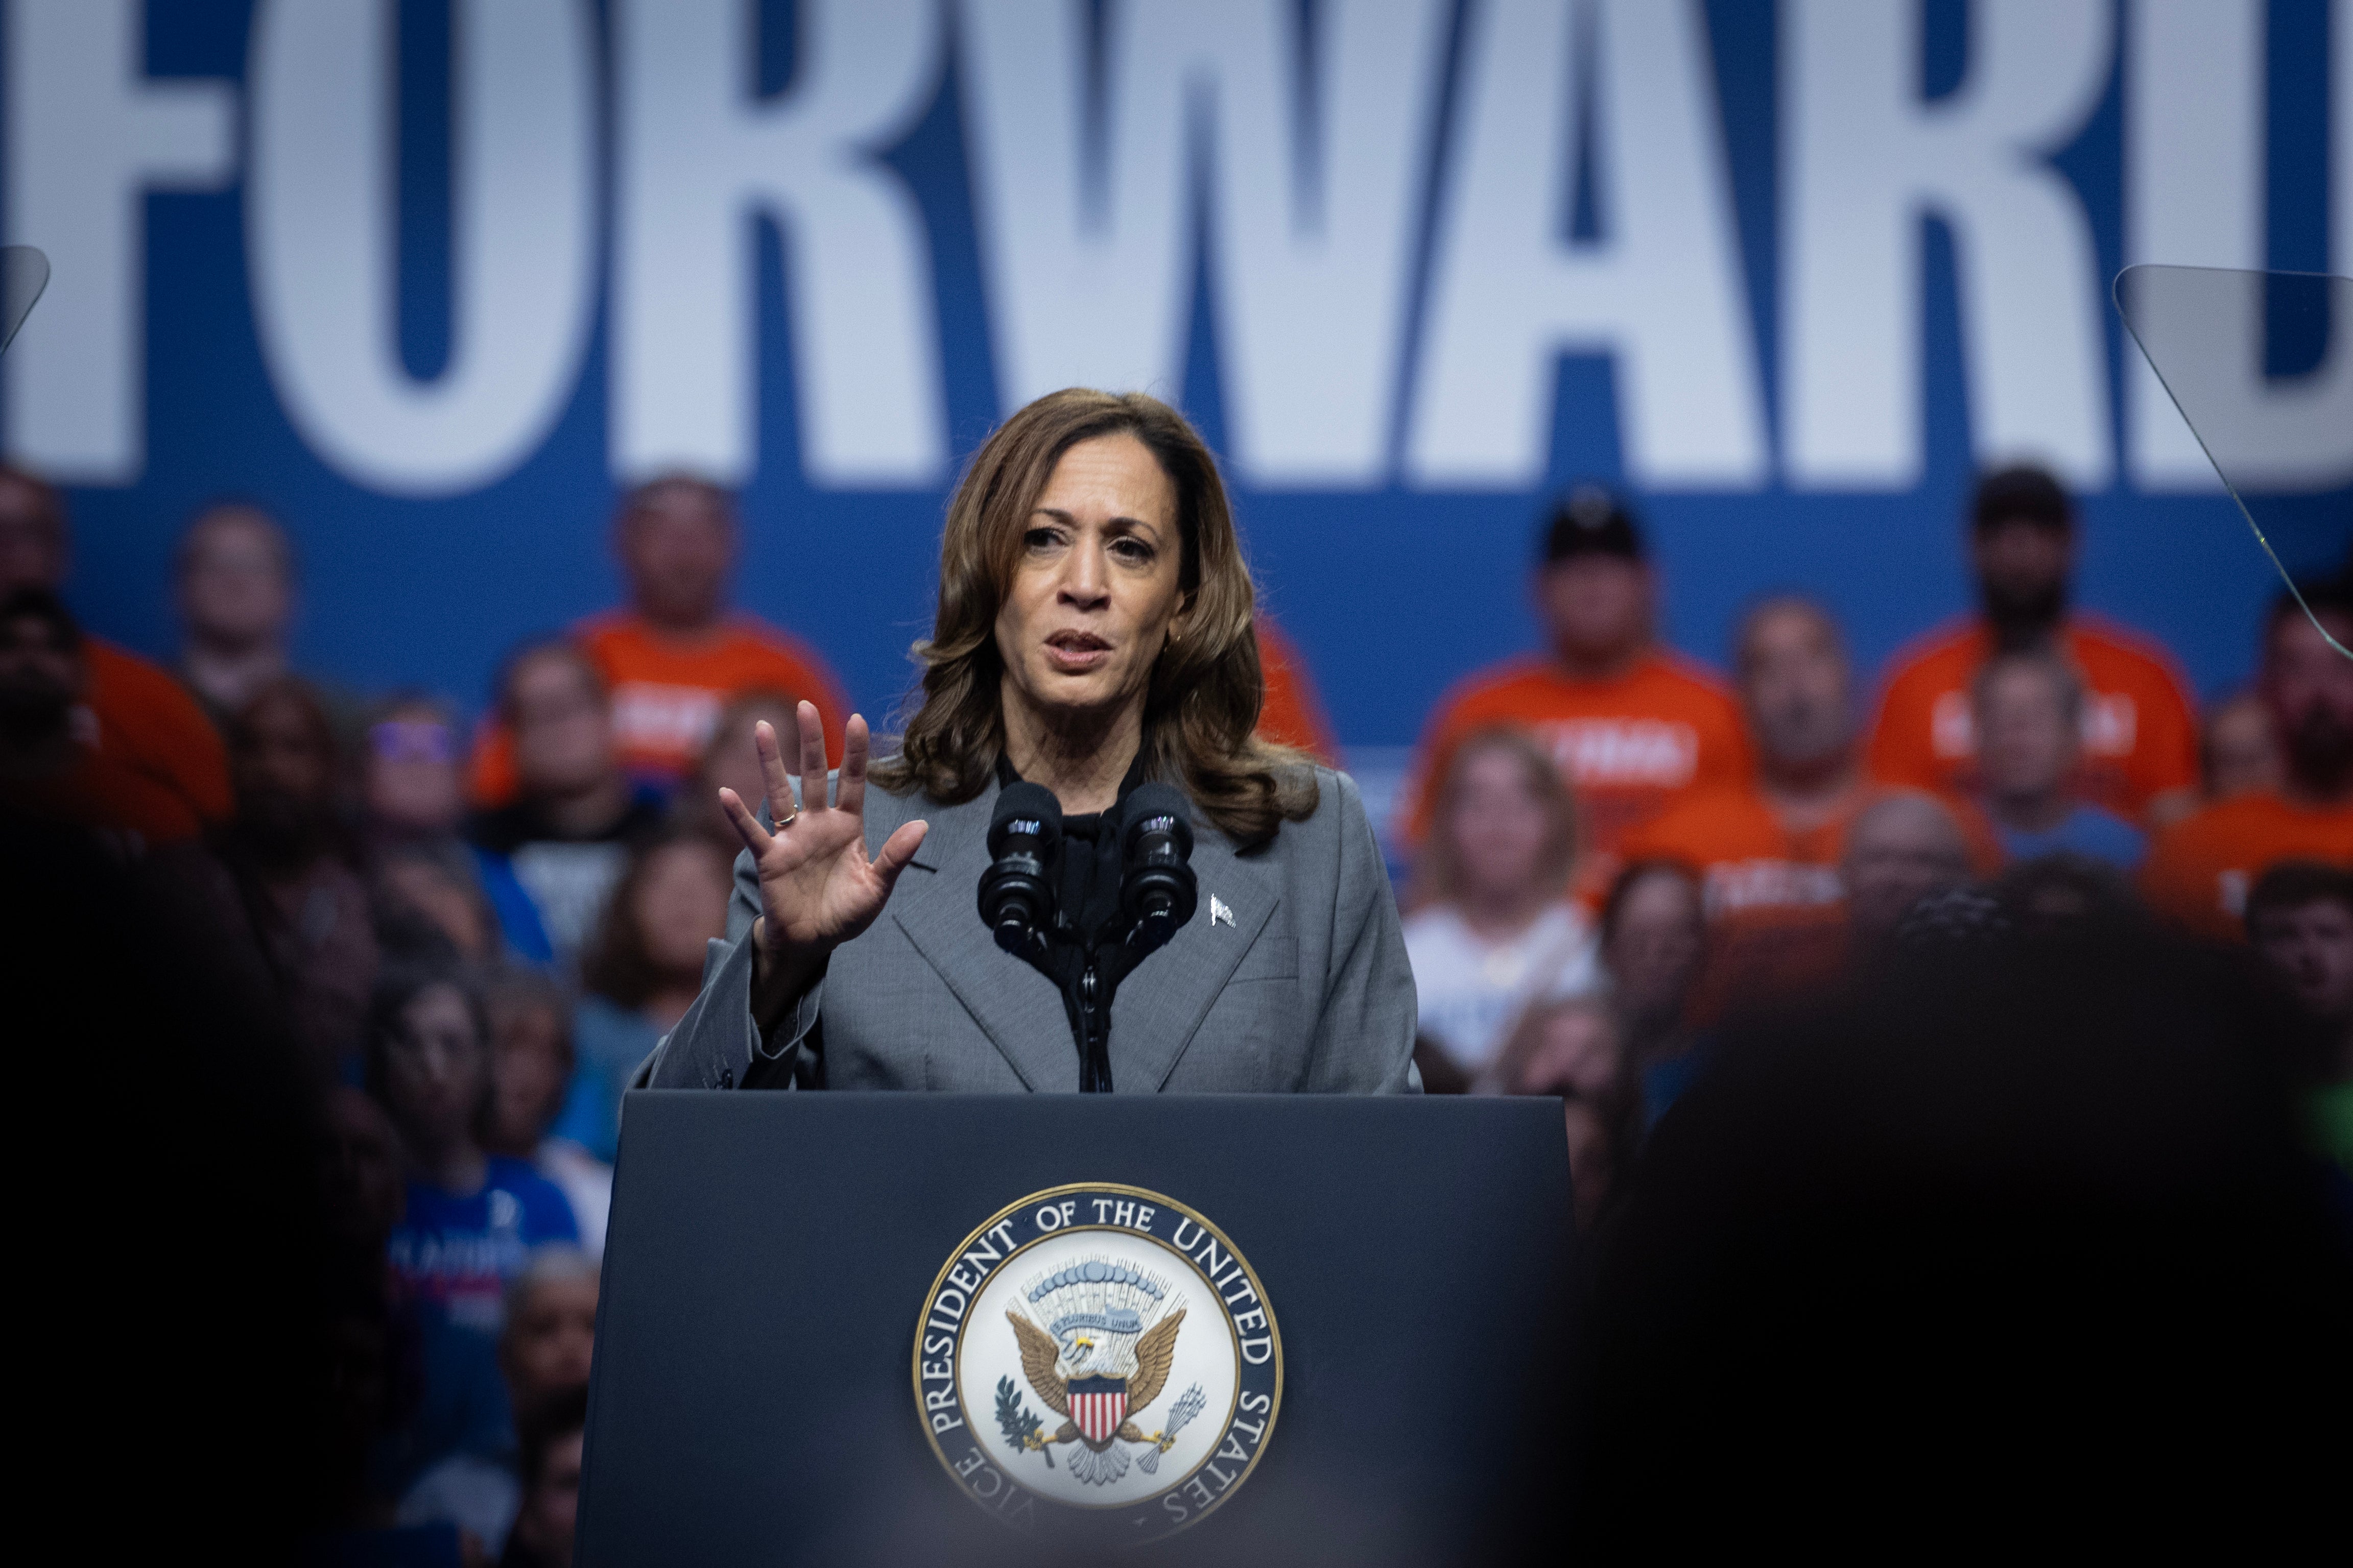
[555,827,748,1161]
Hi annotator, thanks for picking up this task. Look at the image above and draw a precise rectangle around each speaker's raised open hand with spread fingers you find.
[720,703,927,969]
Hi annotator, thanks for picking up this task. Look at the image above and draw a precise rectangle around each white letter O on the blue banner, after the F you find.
[245,0,598,496]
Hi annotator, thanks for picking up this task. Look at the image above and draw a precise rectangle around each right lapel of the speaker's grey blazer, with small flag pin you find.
[1111,823,1282,1091]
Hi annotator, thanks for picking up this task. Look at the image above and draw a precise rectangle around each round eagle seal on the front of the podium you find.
[915,1183,1282,1545]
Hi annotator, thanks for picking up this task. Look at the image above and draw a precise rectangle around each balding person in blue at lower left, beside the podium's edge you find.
[398,1246,598,1561]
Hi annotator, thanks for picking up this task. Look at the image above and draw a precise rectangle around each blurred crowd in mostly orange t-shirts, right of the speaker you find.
[1400,468,2353,1222]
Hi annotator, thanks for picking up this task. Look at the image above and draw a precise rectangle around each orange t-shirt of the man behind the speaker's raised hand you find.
[468,611,849,806]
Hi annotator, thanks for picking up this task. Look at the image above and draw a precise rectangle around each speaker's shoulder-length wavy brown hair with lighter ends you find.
[873,388,1318,844]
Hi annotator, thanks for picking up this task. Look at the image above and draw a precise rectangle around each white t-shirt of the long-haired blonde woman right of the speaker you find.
[1405,903,1602,1072]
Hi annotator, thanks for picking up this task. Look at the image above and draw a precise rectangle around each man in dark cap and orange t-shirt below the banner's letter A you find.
[1405,484,1748,886]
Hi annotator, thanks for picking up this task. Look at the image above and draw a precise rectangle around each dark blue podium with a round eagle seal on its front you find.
[579,1091,1579,1568]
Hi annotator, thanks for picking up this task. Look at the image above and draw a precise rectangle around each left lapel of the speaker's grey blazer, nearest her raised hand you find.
[868,783,1078,1091]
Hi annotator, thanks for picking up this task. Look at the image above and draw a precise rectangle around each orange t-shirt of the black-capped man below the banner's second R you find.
[1871,616,2198,823]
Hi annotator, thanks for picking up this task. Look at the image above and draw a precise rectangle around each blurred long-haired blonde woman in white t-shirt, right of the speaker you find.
[1405,729,1598,1081]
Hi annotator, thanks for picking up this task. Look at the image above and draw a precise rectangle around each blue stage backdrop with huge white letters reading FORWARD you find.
[0,0,2353,759]
